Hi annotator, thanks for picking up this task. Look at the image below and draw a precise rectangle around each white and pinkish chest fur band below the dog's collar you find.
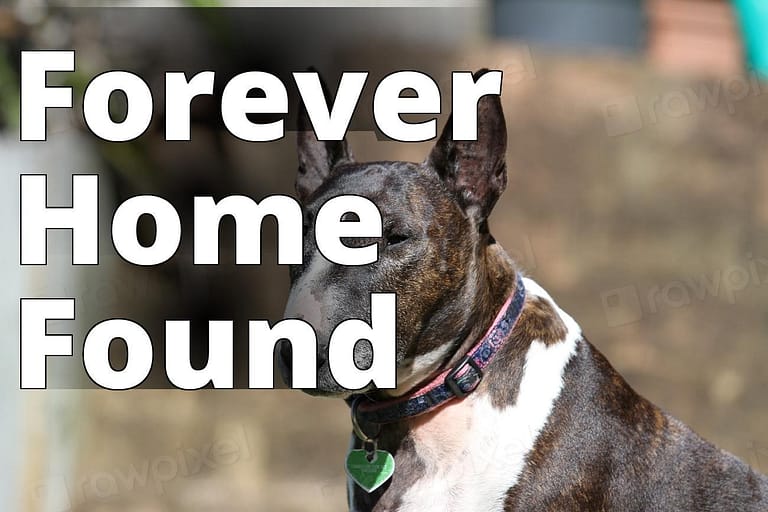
[352,279,581,512]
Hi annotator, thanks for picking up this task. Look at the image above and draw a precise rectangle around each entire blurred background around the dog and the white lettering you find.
[0,0,768,512]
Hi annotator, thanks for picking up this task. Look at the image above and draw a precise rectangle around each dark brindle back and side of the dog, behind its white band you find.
[504,340,768,512]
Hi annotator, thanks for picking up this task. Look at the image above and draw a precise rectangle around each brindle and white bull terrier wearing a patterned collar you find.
[278,72,768,512]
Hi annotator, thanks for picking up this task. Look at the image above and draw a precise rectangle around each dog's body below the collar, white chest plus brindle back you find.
[351,279,768,512]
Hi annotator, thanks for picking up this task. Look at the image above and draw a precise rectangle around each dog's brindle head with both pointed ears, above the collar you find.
[279,74,507,397]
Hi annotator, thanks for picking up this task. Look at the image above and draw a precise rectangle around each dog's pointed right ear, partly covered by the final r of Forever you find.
[427,70,507,225]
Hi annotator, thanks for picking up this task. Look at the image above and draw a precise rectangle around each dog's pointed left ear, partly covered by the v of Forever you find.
[296,68,353,203]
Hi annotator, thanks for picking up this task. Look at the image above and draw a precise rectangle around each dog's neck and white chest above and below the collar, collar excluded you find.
[353,249,580,512]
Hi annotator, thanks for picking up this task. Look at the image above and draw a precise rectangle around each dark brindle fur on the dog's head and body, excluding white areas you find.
[281,71,768,512]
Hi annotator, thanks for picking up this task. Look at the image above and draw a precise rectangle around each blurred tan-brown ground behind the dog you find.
[24,45,768,512]
